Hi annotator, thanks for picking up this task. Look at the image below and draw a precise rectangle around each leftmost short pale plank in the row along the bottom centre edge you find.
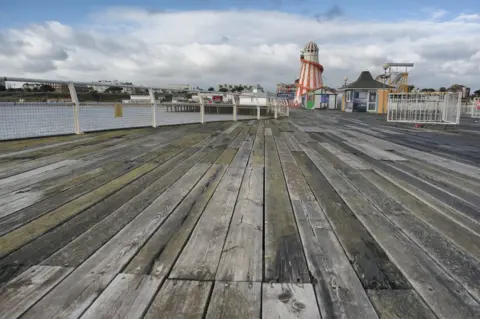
[82,274,162,319]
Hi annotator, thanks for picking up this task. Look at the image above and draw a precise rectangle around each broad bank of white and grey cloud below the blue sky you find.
[0,8,480,88]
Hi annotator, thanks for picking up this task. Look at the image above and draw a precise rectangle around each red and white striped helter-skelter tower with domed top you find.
[295,42,323,103]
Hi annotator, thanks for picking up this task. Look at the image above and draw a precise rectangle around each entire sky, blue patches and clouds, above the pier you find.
[0,0,480,90]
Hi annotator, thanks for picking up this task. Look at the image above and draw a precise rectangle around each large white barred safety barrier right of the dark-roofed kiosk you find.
[387,92,462,125]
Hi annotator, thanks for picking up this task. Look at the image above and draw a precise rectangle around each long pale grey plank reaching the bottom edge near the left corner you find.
[20,164,210,318]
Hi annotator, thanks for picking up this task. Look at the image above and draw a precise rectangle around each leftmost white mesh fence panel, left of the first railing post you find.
[0,102,75,140]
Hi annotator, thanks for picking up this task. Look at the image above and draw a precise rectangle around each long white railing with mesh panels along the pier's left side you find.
[0,78,289,140]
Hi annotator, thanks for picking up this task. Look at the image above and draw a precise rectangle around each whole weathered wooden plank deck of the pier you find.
[0,111,480,319]
